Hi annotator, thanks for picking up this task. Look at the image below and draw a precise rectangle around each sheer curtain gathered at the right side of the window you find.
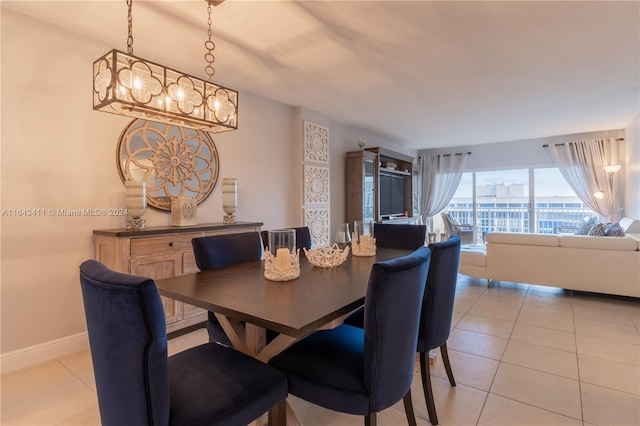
[549,139,622,222]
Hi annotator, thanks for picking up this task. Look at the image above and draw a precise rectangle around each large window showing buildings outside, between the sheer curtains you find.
[445,168,595,243]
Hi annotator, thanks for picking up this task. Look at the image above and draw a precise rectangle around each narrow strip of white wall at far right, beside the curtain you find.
[624,114,640,219]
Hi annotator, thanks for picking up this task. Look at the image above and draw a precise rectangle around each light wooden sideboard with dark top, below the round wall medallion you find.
[93,222,262,333]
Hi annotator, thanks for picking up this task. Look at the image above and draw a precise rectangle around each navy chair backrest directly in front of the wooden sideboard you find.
[191,232,262,271]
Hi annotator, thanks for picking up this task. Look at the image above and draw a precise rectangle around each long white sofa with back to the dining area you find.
[459,218,640,297]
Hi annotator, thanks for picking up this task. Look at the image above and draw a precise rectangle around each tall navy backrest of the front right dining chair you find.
[364,247,431,412]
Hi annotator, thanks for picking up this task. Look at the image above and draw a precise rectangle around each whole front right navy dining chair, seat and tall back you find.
[269,247,431,425]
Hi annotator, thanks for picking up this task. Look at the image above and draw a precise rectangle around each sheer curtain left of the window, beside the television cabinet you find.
[420,153,469,229]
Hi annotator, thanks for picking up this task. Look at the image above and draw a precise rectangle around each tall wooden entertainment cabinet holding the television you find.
[346,148,413,223]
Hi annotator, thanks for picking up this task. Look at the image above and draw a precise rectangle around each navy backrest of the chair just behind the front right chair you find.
[417,235,461,352]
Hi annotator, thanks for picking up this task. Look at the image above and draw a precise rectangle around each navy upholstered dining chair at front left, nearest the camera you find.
[80,260,287,426]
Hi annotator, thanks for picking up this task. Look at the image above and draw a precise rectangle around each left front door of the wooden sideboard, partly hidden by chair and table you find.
[131,254,182,324]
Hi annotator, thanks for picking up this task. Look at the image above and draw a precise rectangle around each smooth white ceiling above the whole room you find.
[2,0,640,149]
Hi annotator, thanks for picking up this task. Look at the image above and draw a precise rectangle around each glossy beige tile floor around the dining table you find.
[0,276,640,426]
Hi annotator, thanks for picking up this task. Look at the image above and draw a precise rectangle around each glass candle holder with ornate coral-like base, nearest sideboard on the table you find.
[264,229,300,281]
